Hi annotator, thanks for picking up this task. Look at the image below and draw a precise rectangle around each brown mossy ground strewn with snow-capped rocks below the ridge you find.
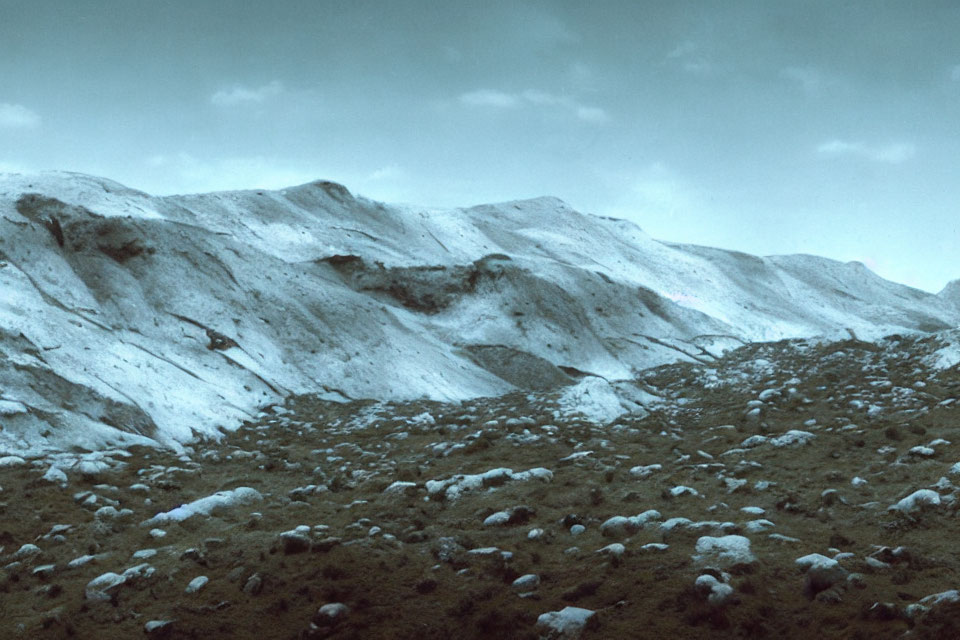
[0,337,960,638]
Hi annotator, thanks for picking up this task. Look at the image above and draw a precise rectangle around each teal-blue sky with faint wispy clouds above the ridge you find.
[0,0,960,292]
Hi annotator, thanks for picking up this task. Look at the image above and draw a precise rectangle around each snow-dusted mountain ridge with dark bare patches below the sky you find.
[0,173,960,452]
